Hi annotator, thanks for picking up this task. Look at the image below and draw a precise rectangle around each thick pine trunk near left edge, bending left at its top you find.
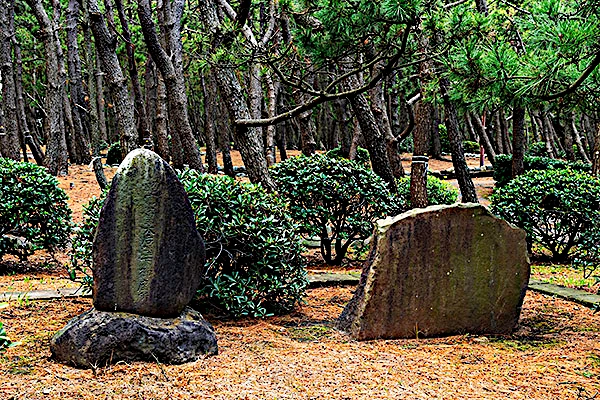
[27,0,69,176]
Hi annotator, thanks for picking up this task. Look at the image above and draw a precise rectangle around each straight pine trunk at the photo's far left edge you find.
[0,0,21,161]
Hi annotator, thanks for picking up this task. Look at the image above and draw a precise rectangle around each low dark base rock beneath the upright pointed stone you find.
[50,307,218,368]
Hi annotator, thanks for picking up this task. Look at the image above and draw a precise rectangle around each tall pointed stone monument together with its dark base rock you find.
[50,149,217,367]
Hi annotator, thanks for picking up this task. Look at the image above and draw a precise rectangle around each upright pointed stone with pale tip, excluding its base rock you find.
[93,149,205,317]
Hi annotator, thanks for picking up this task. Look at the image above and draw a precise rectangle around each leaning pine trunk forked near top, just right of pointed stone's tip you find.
[137,0,204,172]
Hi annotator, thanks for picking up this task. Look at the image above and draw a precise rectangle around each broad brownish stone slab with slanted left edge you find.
[338,204,529,340]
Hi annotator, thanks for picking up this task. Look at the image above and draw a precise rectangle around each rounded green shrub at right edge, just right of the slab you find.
[491,169,600,261]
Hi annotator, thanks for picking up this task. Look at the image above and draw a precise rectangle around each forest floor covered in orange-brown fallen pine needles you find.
[0,154,600,399]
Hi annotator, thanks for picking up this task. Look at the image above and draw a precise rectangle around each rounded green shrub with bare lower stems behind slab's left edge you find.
[271,154,401,265]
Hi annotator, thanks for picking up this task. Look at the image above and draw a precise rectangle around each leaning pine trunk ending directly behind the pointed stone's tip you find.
[89,0,137,157]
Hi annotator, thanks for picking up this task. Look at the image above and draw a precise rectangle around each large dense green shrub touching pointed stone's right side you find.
[181,171,307,316]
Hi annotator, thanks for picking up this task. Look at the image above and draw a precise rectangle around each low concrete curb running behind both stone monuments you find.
[0,273,600,309]
